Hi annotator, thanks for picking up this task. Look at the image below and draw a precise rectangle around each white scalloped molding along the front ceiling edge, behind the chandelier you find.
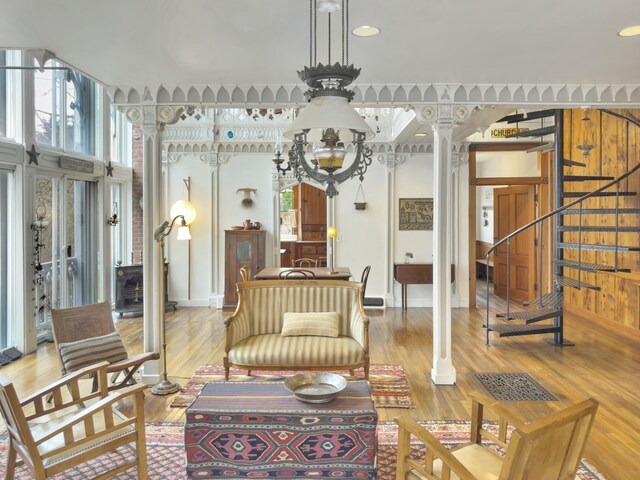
[106,83,640,108]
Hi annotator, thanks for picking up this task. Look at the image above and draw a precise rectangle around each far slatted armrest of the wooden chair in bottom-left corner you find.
[20,362,109,418]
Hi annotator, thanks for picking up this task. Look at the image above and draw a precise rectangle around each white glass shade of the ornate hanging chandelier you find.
[284,96,373,143]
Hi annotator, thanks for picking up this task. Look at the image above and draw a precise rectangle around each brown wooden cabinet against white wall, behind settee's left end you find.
[224,230,266,307]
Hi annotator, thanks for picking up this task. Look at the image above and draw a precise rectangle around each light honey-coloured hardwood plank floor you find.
[1,307,640,480]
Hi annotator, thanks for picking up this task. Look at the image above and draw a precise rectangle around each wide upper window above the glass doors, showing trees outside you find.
[34,61,102,156]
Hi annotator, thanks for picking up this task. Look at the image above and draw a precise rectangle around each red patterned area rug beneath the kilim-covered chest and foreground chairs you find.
[0,420,604,480]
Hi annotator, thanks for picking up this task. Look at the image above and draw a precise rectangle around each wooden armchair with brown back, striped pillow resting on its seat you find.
[51,302,160,390]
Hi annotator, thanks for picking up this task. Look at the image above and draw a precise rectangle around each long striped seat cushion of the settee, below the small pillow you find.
[229,333,364,367]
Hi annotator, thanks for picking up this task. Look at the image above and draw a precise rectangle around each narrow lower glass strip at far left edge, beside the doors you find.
[0,170,13,349]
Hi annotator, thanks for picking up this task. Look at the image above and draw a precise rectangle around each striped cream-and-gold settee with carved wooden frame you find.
[224,280,369,380]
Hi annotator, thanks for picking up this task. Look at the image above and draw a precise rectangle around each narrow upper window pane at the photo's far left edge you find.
[0,50,22,141]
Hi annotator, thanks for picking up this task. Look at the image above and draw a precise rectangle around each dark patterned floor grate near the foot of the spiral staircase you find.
[474,373,558,401]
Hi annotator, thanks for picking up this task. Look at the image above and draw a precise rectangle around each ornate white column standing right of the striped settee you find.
[416,104,469,385]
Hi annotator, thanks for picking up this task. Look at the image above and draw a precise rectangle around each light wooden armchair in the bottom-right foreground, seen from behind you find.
[396,392,598,480]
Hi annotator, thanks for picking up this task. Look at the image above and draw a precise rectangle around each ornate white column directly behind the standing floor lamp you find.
[125,104,181,384]
